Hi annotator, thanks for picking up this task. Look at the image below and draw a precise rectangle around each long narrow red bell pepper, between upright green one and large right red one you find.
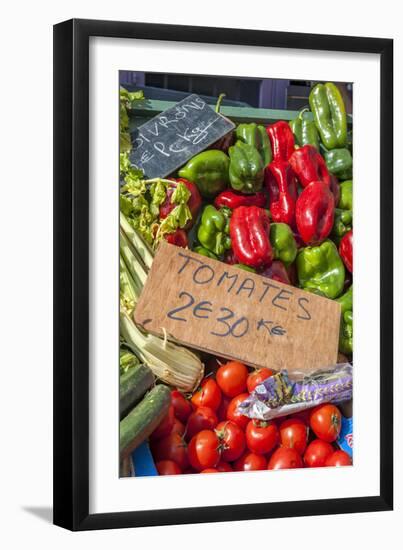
[265,161,297,226]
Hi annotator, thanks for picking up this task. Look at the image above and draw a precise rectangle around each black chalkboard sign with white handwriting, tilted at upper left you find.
[130,94,235,178]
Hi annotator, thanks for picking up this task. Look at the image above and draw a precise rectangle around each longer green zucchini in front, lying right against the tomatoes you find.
[119,384,171,459]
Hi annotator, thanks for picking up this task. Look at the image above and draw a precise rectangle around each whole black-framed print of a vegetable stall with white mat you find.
[54,20,393,530]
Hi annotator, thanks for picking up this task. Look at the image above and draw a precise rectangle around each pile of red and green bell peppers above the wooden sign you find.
[164,82,353,360]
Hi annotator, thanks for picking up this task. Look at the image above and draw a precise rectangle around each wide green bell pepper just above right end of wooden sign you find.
[296,239,345,298]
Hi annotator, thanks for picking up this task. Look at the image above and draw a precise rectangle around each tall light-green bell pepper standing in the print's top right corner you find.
[309,82,347,149]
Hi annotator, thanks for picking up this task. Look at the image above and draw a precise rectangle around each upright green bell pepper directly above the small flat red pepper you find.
[229,140,264,193]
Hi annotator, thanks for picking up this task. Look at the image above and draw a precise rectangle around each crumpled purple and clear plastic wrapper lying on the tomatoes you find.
[238,363,353,420]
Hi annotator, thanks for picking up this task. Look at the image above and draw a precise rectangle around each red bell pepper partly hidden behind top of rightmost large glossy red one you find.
[290,145,330,187]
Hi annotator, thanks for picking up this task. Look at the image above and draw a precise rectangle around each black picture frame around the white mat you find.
[54,19,393,530]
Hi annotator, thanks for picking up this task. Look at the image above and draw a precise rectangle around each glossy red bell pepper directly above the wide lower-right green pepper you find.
[295,181,334,245]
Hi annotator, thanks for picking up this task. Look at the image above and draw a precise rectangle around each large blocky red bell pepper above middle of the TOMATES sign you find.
[229,206,273,268]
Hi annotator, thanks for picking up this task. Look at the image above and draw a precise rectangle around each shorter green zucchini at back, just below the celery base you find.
[119,365,154,420]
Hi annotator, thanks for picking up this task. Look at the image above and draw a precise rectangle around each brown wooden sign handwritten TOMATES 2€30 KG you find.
[135,242,340,373]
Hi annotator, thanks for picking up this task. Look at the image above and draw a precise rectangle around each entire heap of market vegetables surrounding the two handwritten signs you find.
[119,83,353,475]
